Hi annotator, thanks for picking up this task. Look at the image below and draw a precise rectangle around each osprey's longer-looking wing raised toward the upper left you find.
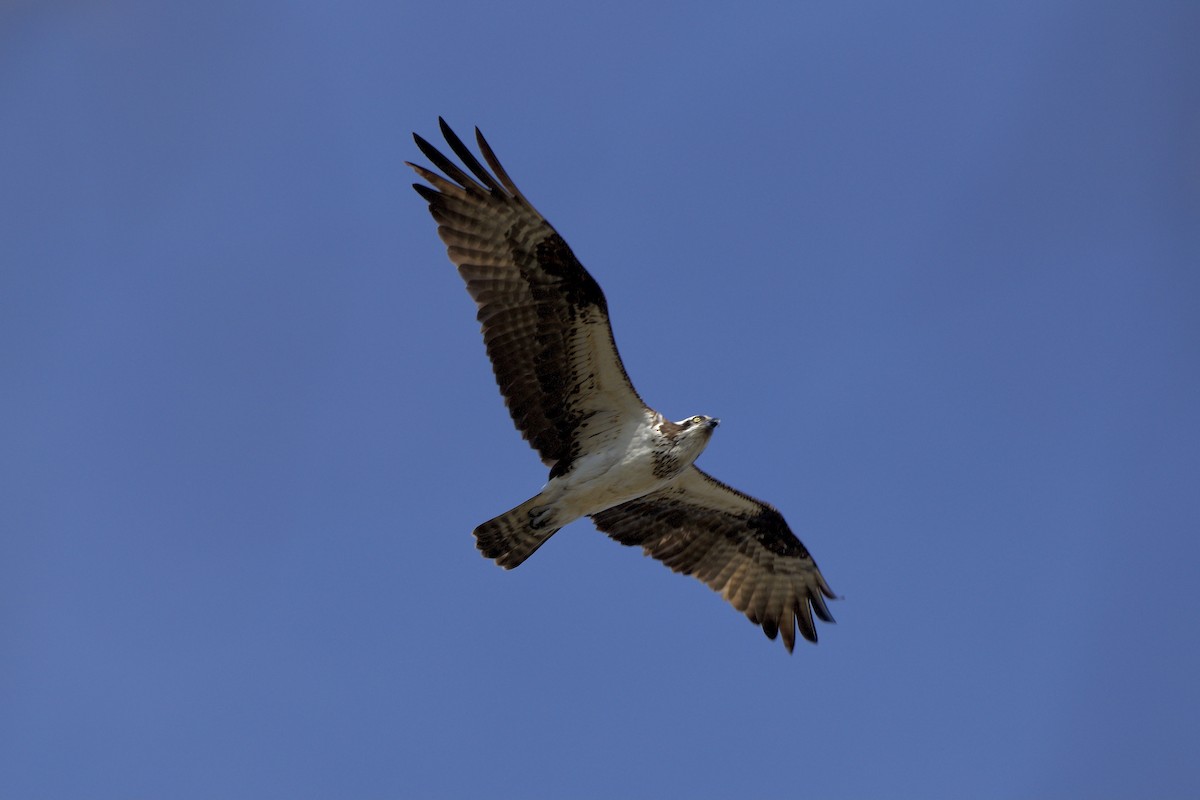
[408,119,646,475]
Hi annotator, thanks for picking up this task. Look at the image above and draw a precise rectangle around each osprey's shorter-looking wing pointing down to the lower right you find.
[592,467,835,652]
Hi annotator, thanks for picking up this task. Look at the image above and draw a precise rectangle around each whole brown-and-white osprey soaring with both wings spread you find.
[406,118,834,652]
